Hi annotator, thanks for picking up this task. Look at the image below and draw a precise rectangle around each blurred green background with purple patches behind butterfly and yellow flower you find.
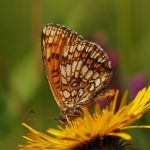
[0,0,150,150]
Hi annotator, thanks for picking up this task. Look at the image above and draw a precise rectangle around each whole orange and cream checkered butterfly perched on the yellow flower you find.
[41,24,114,122]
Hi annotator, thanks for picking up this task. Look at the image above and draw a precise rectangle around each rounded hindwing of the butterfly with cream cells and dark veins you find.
[60,40,112,107]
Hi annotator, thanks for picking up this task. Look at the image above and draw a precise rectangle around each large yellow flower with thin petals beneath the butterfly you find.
[19,87,150,150]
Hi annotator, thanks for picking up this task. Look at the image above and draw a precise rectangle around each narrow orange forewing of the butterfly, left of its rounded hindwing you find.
[41,24,81,109]
